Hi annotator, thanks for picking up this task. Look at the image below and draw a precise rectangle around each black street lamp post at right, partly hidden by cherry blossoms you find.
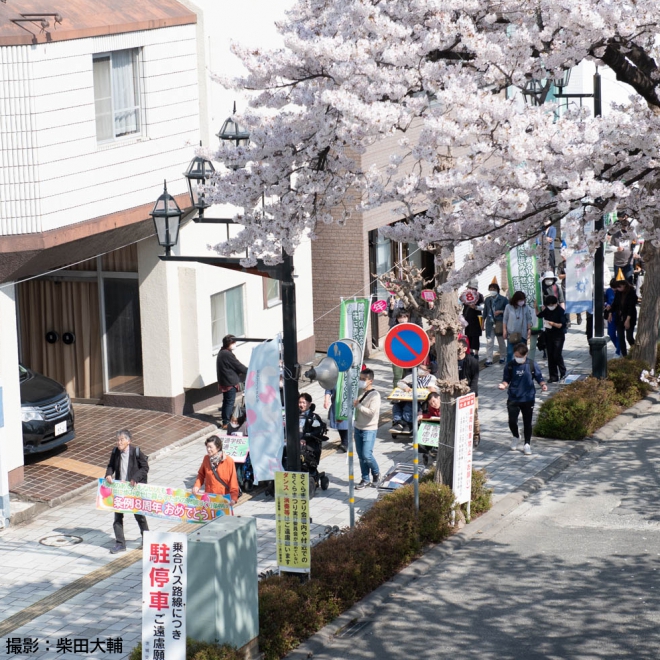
[523,67,607,379]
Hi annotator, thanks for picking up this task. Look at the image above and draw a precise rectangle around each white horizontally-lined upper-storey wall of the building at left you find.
[0,25,199,235]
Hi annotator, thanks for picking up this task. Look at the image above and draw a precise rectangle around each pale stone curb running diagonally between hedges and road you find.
[285,392,660,660]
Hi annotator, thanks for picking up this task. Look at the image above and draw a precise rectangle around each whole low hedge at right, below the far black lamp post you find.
[534,358,651,440]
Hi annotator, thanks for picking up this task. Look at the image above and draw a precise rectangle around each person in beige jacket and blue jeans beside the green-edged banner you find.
[353,368,380,490]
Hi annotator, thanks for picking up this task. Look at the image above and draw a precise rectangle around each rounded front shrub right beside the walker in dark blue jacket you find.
[534,378,619,440]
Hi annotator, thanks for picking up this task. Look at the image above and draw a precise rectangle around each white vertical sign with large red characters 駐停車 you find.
[142,532,188,660]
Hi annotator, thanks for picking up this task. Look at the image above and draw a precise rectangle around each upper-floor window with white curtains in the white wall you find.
[94,48,141,142]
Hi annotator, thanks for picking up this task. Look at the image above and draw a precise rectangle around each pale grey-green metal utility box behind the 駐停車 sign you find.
[186,516,259,648]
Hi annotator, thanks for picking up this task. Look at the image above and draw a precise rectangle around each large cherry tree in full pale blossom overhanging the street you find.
[208,0,660,481]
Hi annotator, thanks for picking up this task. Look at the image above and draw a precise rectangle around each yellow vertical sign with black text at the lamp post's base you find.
[275,472,311,573]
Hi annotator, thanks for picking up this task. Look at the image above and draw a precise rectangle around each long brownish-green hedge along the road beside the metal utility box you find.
[130,470,492,660]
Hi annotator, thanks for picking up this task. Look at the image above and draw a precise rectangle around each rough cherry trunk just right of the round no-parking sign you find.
[433,251,464,487]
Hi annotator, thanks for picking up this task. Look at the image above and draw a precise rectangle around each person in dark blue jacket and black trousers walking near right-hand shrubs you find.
[498,343,548,456]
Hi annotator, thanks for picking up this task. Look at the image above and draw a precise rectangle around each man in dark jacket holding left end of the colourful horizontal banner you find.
[105,429,149,555]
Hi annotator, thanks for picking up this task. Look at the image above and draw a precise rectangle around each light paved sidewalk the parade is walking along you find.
[0,325,613,660]
